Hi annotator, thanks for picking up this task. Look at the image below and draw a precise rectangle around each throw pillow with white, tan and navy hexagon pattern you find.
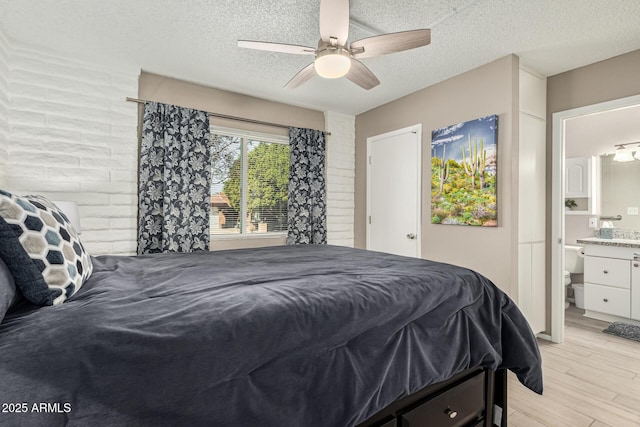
[0,190,93,305]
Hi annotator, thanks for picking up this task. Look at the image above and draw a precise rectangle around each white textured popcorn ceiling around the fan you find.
[0,0,640,114]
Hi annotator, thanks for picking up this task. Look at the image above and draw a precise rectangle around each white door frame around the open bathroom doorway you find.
[551,95,640,343]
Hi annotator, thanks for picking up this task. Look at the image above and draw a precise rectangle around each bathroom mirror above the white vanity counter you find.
[600,154,640,230]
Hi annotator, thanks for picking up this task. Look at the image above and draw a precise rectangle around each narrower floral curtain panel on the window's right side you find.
[287,127,327,245]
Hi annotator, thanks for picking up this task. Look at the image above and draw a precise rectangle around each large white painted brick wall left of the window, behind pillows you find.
[0,38,139,255]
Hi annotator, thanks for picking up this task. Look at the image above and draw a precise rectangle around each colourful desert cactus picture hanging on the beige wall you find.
[431,114,498,227]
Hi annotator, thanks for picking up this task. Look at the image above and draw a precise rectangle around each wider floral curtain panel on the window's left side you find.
[138,102,211,254]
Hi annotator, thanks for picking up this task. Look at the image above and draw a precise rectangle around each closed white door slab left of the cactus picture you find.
[367,125,422,257]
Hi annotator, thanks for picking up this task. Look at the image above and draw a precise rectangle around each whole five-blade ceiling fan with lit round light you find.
[238,0,431,90]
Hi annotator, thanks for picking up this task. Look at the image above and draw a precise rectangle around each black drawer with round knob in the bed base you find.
[401,373,485,427]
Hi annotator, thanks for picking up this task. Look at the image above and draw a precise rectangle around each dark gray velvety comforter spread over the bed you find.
[0,246,542,427]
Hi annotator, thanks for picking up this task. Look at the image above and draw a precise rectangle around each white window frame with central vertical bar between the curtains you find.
[209,125,289,241]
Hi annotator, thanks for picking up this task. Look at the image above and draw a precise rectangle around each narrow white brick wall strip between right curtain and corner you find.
[325,112,355,247]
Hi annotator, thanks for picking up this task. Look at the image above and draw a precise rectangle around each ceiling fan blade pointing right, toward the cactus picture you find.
[350,29,431,58]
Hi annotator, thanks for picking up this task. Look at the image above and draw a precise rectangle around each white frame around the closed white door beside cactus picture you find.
[365,123,422,258]
